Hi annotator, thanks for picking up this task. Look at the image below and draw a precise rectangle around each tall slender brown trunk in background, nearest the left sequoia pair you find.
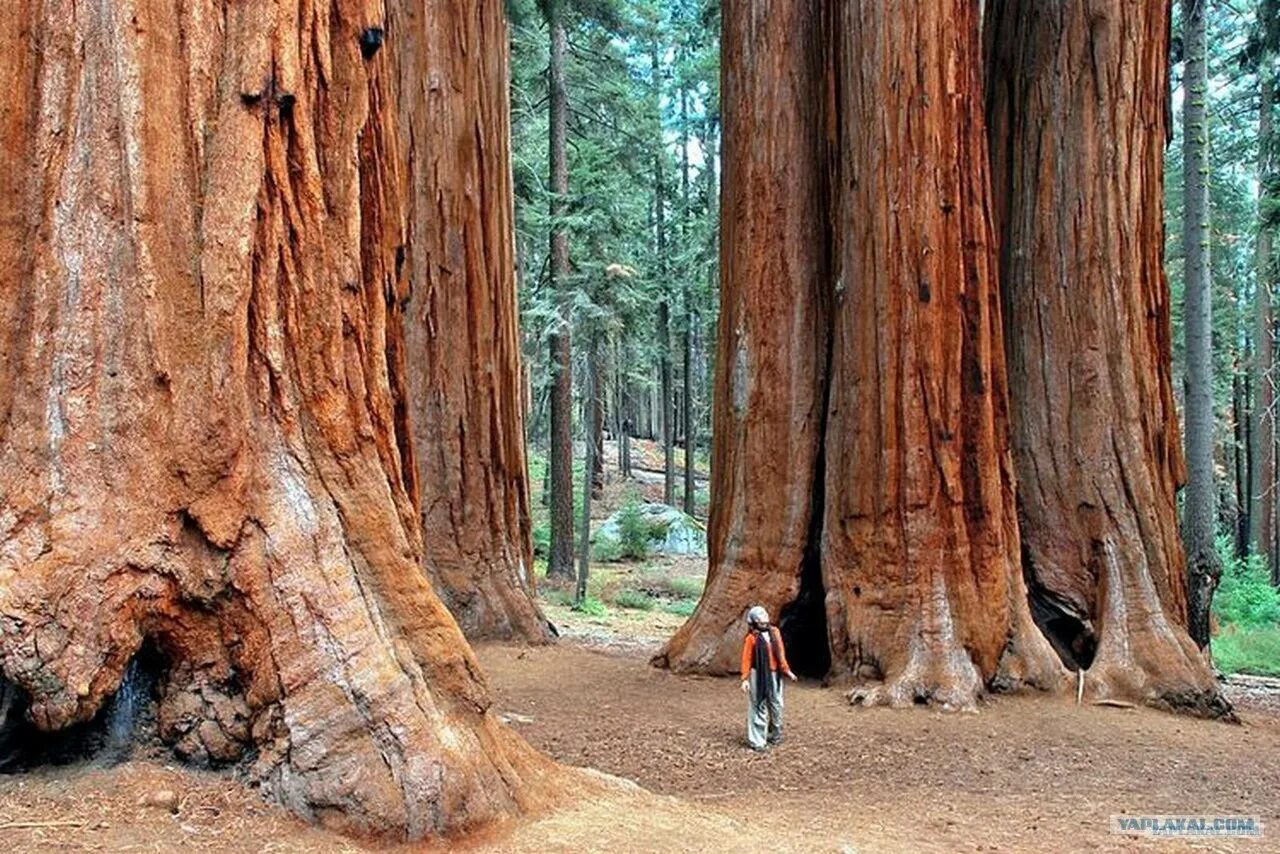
[547,15,573,577]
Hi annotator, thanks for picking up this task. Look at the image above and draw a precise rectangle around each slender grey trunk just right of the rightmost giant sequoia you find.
[1181,0,1222,649]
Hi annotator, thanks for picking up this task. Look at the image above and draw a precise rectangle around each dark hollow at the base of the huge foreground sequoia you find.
[0,640,168,773]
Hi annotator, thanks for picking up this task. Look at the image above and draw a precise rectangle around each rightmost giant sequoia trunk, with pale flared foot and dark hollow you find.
[987,0,1225,714]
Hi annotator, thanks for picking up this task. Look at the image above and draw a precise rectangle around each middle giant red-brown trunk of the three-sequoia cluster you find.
[822,0,1061,708]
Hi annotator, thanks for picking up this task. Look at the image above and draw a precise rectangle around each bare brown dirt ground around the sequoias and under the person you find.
[0,609,1280,854]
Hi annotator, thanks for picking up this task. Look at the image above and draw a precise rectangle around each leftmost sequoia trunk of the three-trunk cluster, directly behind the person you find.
[650,0,829,673]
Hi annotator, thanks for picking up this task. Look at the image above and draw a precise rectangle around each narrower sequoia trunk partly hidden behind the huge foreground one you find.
[397,0,548,641]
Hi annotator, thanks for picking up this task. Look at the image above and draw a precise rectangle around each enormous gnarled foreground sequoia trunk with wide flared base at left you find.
[0,0,552,837]
